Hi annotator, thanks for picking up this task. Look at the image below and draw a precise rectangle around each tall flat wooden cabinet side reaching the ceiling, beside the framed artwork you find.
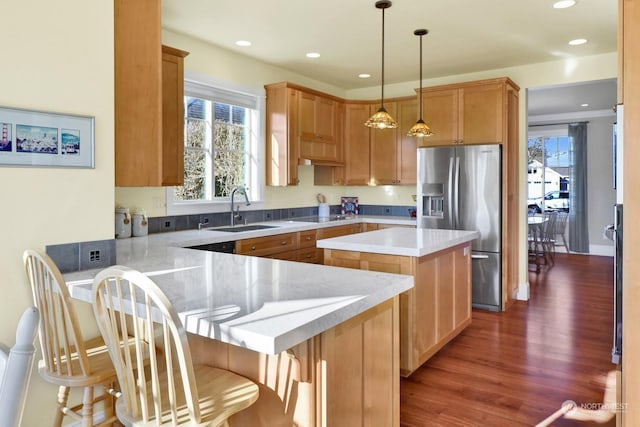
[114,0,162,187]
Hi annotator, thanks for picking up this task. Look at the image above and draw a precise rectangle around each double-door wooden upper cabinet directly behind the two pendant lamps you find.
[371,98,418,185]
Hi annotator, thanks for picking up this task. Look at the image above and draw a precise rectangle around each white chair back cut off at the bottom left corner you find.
[0,307,40,427]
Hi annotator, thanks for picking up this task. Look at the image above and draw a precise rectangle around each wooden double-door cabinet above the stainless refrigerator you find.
[422,78,519,146]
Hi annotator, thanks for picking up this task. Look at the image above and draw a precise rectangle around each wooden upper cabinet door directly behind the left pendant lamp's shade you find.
[370,102,398,185]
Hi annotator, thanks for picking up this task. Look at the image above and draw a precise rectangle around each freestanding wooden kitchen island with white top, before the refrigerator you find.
[317,228,479,376]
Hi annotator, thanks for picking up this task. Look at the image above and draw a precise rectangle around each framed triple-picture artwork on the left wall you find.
[0,107,94,168]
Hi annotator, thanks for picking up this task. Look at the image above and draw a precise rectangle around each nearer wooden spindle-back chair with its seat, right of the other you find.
[93,266,258,426]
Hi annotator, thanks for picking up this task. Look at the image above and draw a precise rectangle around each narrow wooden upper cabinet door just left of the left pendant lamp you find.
[344,104,370,185]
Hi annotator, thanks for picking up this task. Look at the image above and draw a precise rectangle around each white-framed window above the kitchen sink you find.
[167,74,264,215]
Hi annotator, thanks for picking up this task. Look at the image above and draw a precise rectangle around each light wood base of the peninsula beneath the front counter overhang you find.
[189,297,400,427]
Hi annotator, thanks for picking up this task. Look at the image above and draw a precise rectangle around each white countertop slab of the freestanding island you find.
[316,228,480,257]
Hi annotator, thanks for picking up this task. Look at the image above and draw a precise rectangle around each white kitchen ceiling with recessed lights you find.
[162,0,618,115]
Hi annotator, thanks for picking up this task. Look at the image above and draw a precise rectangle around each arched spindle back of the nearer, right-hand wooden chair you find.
[93,266,201,425]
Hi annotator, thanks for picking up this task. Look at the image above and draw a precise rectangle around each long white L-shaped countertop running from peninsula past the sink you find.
[64,217,415,354]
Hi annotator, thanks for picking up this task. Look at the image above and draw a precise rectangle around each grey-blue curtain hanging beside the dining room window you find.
[569,122,589,253]
